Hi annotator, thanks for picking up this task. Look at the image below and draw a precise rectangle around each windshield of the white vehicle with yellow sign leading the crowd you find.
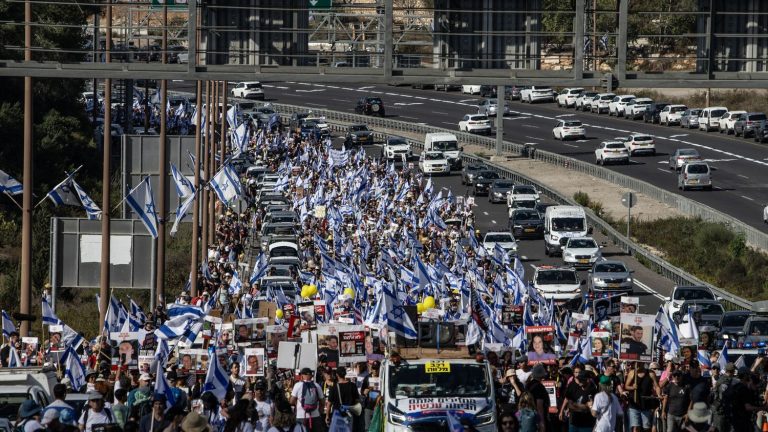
[388,361,491,399]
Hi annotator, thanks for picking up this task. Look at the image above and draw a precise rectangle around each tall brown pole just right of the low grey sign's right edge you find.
[156,6,168,305]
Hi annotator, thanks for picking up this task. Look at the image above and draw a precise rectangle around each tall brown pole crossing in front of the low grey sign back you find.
[99,2,112,323]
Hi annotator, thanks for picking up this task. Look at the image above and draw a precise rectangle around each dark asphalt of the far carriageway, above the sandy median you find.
[258,82,768,235]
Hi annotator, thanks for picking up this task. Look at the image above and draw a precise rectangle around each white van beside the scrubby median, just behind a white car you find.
[544,206,590,256]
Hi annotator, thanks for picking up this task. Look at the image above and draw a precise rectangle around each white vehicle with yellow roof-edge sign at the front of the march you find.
[380,358,496,432]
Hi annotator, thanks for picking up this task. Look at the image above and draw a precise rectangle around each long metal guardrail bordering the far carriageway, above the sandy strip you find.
[254,99,768,251]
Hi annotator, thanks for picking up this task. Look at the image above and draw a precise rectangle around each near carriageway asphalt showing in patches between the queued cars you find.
[352,139,674,314]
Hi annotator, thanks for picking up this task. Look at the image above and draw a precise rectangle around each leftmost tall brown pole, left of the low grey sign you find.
[19,0,34,337]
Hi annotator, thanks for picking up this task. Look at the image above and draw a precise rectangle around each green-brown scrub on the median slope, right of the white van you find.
[573,192,768,301]
